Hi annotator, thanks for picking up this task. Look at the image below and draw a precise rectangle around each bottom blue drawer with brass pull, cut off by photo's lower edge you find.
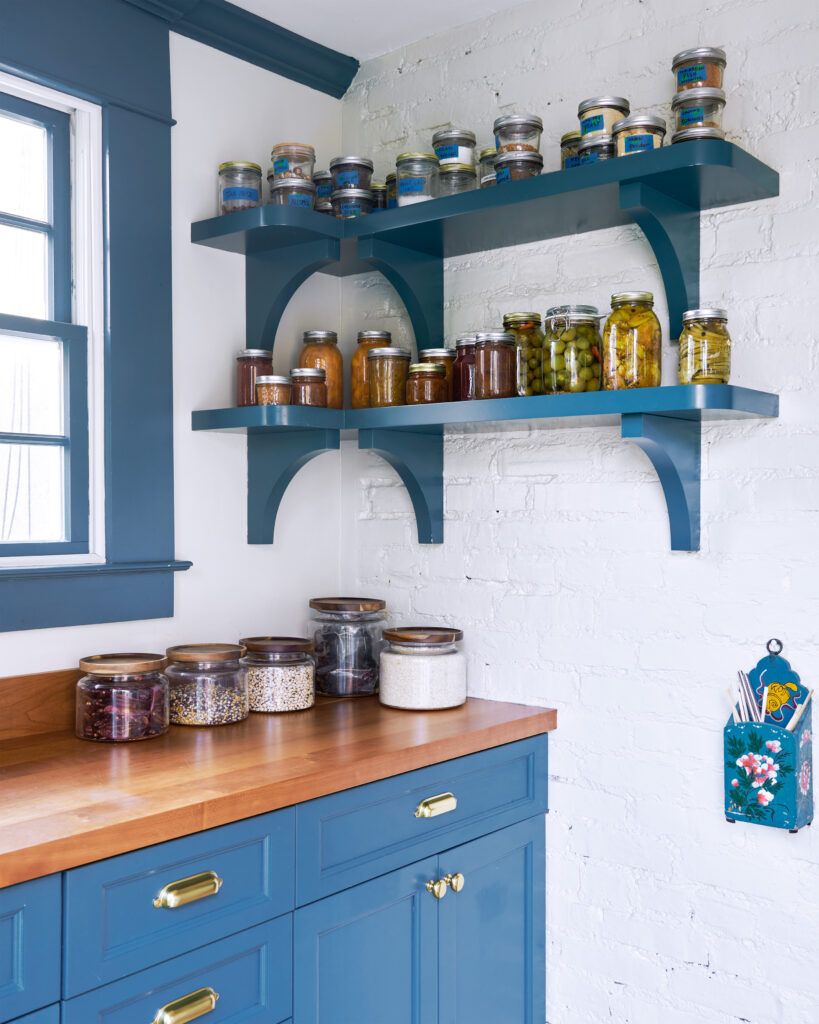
[62,914,293,1024]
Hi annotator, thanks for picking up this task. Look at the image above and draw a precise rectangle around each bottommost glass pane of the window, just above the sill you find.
[0,444,66,544]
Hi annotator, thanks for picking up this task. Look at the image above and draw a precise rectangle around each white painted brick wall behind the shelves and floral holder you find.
[343,0,819,1024]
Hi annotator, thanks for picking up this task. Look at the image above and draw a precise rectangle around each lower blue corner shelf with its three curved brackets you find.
[192,384,779,551]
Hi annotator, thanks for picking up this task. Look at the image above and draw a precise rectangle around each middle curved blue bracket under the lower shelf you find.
[358,426,443,544]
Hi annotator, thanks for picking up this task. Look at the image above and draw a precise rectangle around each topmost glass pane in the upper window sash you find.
[0,115,48,220]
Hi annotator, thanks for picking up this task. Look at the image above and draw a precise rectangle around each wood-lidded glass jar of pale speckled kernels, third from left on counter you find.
[241,637,315,712]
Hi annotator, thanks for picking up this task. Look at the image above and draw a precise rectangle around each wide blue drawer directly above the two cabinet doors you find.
[296,735,547,906]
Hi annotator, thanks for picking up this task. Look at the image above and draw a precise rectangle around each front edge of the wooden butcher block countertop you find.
[0,708,557,888]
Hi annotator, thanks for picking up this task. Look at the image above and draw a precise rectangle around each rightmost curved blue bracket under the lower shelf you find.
[621,413,701,551]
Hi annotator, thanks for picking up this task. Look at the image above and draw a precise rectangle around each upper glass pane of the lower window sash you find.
[0,333,66,434]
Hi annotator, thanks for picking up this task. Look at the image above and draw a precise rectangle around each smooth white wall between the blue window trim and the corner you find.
[0,35,341,675]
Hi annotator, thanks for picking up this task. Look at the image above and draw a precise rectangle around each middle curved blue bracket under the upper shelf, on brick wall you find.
[358,238,443,349]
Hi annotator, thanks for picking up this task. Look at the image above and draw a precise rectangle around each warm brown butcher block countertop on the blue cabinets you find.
[0,697,557,887]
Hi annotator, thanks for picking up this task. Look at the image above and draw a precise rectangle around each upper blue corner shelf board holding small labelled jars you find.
[190,139,779,274]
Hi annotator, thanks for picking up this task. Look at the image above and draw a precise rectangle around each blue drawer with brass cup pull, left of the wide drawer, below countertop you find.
[63,808,295,997]
